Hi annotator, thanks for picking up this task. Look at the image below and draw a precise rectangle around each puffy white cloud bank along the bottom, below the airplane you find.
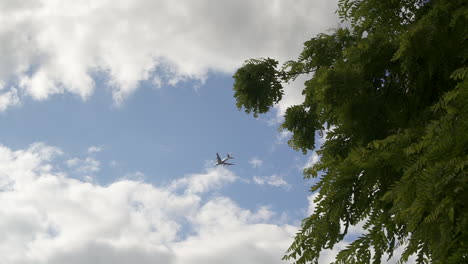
[0,143,297,264]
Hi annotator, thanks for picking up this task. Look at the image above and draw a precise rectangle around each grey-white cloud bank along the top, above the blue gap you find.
[0,0,338,110]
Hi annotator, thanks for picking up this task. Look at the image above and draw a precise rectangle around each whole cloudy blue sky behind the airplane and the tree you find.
[0,0,414,264]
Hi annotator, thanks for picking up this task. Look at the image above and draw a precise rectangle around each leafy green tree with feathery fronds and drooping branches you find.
[233,0,468,264]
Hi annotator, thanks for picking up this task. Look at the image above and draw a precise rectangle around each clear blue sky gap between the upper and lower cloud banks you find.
[0,71,310,214]
